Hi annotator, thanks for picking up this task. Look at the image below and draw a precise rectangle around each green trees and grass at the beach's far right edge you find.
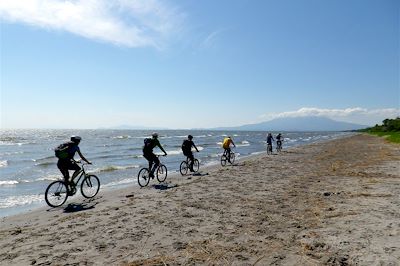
[360,117,400,143]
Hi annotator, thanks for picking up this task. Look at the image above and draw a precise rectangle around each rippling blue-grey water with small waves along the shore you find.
[0,130,347,216]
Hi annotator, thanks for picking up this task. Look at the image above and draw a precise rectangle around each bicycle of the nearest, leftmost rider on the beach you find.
[45,161,100,208]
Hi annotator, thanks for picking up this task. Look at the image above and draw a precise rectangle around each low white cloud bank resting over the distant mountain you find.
[261,107,400,125]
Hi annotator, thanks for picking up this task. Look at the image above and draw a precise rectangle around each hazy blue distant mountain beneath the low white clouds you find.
[215,116,368,131]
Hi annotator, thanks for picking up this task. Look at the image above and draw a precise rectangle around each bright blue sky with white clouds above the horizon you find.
[0,0,400,129]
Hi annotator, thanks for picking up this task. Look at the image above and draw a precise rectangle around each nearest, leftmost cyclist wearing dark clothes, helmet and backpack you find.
[56,136,92,192]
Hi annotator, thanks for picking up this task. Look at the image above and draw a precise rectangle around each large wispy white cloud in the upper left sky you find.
[0,0,185,48]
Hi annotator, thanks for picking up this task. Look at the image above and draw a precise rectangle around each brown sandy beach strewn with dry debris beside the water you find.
[0,134,400,265]
